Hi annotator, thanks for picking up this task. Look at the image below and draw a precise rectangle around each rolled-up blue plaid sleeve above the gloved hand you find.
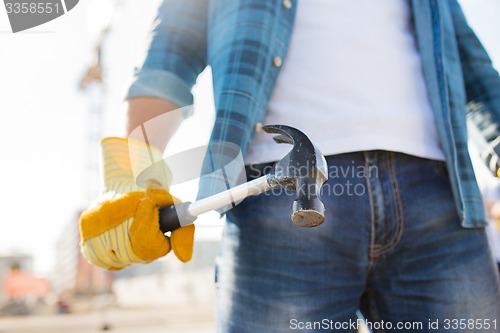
[126,0,208,107]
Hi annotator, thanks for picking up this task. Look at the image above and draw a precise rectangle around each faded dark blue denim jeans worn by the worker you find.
[216,151,500,333]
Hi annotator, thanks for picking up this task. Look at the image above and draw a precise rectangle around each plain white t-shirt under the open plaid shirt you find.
[246,0,444,163]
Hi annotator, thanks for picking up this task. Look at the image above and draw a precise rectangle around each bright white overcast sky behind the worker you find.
[0,0,500,273]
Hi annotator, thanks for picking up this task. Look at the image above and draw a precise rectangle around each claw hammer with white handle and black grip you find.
[160,125,328,233]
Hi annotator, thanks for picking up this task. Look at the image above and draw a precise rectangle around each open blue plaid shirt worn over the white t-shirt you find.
[127,0,500,227]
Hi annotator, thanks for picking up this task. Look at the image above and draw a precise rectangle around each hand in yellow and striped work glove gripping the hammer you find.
[80,138,194,270]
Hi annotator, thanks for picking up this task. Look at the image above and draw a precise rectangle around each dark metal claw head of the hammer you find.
[262,125,328,228]
